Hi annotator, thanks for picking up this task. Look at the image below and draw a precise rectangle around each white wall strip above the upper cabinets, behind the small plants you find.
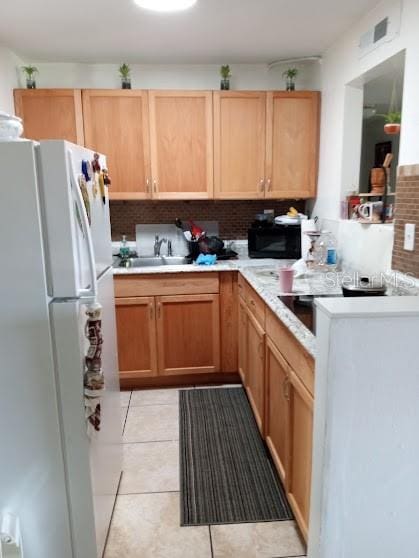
[13,62,320,89]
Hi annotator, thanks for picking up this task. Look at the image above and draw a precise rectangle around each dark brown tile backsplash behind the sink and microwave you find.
[111,200,305,240]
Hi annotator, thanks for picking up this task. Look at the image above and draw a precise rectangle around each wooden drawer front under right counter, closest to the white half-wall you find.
[266,309,314,395]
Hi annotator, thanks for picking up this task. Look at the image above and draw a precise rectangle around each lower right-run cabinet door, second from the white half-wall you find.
[265,337,289,484]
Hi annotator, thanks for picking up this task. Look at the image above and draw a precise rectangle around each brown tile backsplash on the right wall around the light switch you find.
[392,165,419,277]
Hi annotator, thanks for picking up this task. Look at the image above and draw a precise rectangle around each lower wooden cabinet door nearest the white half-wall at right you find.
[286,369,313,540]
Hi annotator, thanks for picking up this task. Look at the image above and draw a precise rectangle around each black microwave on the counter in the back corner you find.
[247,225,301,260]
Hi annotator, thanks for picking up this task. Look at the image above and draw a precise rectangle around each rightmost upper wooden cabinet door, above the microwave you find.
[266,91,320,198]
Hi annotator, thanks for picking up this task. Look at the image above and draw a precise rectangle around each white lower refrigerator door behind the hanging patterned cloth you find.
[51,270,122,558]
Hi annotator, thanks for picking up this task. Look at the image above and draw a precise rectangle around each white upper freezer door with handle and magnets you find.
[38,141,112,298]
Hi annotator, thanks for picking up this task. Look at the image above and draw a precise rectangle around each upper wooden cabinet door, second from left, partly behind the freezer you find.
[83,89,151,200]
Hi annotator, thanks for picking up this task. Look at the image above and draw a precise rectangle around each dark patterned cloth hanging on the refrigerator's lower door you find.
[84,303,105,435]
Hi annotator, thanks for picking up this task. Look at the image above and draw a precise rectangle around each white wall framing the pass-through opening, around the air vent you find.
[314,0,419,219]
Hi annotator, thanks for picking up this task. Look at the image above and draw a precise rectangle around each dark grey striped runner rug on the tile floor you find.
[179,388,293,526]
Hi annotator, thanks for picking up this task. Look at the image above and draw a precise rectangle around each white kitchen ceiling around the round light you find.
[0,0,378,64]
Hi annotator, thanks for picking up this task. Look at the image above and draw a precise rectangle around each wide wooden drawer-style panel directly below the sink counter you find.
[114,272,220,298]
